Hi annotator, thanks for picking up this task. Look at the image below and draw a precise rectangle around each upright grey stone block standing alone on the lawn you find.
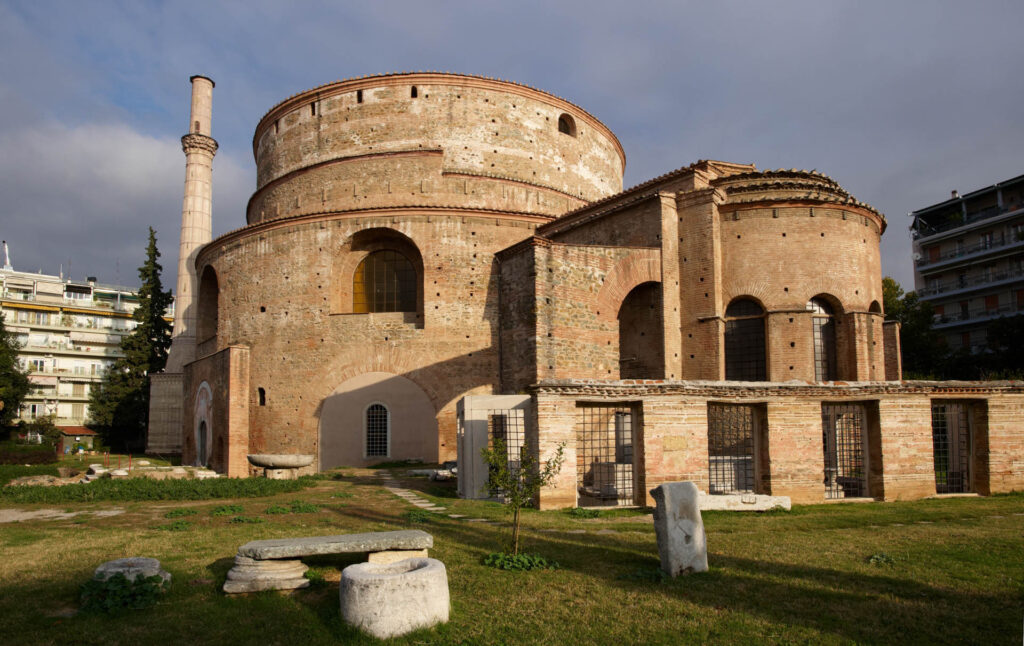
[650,482,708,576]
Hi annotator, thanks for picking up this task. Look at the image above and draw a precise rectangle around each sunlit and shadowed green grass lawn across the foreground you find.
[0,469,1024,646]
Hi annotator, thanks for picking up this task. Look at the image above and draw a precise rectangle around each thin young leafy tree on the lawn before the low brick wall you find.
[481,438,565,556]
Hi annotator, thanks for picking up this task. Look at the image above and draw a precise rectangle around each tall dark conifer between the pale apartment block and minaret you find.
[89,227,172,448]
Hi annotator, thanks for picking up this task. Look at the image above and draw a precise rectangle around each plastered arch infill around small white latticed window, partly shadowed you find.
[319,373,437,470]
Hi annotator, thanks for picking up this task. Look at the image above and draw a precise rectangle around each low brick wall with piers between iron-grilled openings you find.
[534,380,1024,508]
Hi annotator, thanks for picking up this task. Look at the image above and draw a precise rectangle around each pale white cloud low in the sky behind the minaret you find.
[0,123,251,286]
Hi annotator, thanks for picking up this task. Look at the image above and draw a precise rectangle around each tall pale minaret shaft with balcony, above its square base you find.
[165,76,217,373]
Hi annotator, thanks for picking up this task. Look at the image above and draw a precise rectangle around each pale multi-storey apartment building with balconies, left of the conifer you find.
[0,263,173,427]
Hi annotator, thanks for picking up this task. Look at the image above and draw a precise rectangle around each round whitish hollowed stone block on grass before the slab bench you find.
[339,558,450,639]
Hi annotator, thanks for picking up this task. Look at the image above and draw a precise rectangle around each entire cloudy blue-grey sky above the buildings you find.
[0,0,1024,287]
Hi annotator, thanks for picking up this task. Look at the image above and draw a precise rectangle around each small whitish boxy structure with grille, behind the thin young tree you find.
[458,395,530,499]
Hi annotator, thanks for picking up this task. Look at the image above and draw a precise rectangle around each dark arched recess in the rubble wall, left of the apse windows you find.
[618,283,665,379]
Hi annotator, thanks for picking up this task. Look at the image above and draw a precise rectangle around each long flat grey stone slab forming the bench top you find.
[239,529,434,560]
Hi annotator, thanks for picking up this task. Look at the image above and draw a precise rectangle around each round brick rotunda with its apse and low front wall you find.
[151,73,1024,507]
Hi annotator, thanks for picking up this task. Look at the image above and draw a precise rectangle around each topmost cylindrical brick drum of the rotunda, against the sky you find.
[249,74,625,222]
